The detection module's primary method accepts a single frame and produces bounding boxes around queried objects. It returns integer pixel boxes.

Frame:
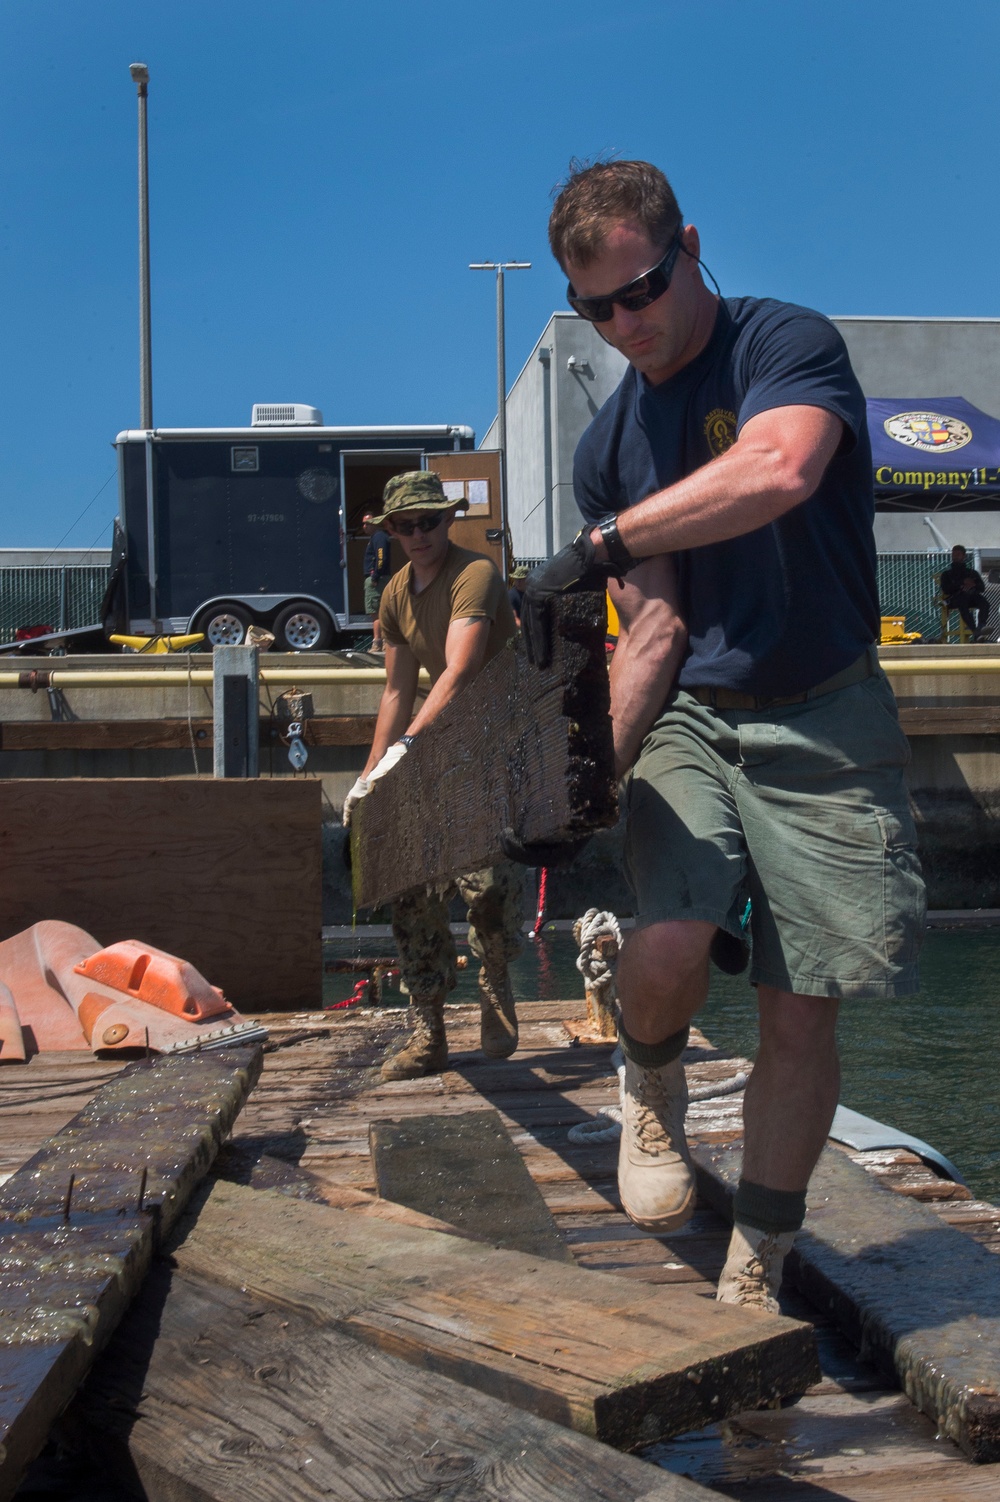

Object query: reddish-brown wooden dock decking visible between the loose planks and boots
[0,1000,1000,1502]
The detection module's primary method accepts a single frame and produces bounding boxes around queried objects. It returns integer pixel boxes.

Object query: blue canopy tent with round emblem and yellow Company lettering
[868,397,1000,511]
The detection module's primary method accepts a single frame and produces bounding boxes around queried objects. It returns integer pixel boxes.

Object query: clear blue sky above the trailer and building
[0,0,1000,547]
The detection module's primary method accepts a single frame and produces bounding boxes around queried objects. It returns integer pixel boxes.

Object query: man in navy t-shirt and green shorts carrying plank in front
[523,162,923,1310]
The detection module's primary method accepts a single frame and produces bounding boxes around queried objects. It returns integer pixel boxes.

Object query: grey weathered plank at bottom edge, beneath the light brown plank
[60,1265,715,1502]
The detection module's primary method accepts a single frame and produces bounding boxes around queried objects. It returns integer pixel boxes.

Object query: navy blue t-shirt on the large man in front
[574,297,878,698]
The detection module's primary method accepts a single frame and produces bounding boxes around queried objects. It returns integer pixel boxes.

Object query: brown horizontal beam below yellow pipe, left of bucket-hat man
[0,715,375,751]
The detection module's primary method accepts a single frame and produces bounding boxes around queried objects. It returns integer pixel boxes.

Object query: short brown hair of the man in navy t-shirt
[548,161,682,267]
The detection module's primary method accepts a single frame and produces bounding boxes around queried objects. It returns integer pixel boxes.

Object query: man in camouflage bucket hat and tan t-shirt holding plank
[344,470,523,1080]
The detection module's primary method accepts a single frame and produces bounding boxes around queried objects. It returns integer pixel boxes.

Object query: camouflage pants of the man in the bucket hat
[392,861,524,1002]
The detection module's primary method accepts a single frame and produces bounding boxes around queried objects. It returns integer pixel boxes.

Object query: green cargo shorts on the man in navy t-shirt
[625,671,925,997]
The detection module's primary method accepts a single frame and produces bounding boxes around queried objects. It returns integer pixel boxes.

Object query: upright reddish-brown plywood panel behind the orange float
[0,778,323,1011]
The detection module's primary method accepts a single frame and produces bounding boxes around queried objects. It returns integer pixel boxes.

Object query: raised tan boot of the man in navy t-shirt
[619,1057,695,1232]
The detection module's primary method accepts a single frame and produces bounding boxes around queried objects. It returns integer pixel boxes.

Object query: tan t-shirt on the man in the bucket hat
[378,542,517,683]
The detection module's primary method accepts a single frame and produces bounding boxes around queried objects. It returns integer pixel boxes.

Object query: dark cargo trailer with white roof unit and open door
[116,407,489,650]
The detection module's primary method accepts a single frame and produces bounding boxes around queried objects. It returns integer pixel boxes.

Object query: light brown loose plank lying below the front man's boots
[171,1184,817,1448]
